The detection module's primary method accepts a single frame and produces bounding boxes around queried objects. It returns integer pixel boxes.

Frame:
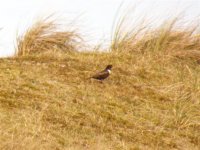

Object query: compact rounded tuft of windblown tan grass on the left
[16,17,82,56]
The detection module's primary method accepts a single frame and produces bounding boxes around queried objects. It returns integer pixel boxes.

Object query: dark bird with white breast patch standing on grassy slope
[90,65,112,81]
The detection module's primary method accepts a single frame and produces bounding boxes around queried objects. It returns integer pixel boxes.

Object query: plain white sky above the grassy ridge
[0,0,200,57]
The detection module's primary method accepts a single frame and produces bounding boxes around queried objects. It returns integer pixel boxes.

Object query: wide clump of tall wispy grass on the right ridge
[111,14,200,59]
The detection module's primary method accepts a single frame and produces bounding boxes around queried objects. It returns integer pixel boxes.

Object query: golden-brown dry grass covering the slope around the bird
[0,13,200,150]
